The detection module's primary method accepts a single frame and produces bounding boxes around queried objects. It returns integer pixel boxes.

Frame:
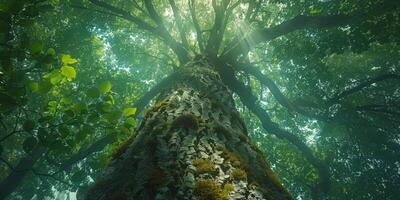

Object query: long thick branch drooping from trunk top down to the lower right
[216,63,330,195]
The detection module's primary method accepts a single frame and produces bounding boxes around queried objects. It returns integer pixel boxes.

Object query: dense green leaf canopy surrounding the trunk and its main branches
[0,0,400,199]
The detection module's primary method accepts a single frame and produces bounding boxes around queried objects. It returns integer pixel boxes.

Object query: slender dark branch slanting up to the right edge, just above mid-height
[328,74,400,105]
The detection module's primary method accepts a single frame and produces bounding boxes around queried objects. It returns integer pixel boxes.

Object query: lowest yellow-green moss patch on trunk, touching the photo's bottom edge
[194,179,228,200]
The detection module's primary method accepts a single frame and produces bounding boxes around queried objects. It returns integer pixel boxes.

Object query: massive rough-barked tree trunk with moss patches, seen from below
[87,61,291,200]
